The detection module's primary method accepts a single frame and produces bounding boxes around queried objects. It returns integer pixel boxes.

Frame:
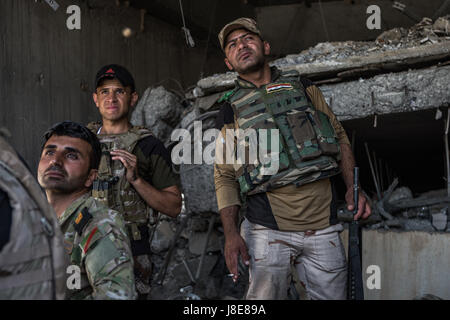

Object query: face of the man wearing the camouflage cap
[225,29,270,74]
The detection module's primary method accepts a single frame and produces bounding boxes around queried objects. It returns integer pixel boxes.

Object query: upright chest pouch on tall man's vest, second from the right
[286,111,322,161]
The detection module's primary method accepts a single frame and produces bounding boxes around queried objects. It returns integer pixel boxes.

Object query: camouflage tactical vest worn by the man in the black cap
[88,122,154,241]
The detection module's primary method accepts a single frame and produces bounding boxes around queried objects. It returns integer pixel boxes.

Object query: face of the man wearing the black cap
[93,79,137,122]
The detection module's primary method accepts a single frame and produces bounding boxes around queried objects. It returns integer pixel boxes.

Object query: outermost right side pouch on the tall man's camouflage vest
[314,110,340,155]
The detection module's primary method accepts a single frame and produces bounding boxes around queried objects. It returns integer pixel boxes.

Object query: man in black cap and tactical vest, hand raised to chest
[88,64,181,299]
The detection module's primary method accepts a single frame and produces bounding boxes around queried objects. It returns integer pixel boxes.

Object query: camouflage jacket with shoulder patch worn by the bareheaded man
[59,194,136,299]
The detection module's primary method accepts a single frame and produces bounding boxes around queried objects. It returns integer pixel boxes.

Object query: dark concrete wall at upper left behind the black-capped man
[0,0,225,170]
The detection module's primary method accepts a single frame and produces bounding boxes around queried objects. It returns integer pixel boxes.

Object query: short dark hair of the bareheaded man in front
[41,121,102,169]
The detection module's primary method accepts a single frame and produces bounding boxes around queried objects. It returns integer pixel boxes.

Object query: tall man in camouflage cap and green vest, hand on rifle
[214,18,371,299]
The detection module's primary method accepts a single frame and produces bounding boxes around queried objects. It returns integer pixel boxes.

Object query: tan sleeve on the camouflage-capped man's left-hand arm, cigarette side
[214,124,241,210]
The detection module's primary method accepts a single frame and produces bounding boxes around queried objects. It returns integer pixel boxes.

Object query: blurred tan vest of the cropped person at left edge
[0,136,68,299]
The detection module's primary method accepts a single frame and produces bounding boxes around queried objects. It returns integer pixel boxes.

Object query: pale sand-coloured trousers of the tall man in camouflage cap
[241,219,347,300]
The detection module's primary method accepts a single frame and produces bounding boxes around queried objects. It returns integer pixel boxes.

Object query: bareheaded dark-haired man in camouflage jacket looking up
[38,122,137,300]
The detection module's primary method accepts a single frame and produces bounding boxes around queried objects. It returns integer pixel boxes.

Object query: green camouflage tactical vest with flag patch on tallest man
[225,71,340,197]
